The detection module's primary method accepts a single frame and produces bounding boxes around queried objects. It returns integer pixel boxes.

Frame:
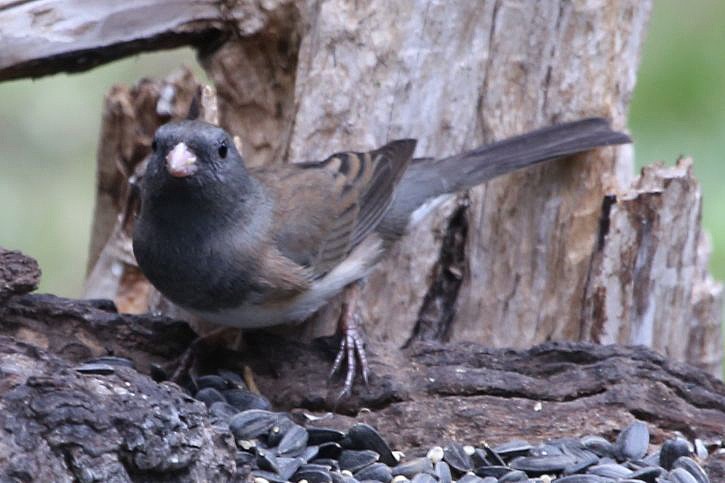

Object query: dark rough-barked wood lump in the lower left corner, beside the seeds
[0,334,236,482]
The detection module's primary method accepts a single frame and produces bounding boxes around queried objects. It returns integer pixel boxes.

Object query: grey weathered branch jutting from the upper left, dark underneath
[0,0,225,80]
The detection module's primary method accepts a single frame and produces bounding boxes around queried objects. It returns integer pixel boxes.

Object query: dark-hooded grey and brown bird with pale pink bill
[133,117,631,397]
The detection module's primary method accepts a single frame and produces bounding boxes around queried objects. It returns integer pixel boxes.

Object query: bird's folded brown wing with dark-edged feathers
[253,139,415,277]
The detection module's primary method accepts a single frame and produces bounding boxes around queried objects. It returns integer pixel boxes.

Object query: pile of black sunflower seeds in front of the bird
[185,372,710,483]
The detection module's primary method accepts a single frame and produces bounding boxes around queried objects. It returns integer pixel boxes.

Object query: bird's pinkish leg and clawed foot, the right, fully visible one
[330,282,368,399]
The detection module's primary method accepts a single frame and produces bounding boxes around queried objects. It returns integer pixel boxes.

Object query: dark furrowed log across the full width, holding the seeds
[0,250,725,481]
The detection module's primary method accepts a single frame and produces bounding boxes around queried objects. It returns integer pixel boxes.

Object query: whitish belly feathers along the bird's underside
[191,235,382,329]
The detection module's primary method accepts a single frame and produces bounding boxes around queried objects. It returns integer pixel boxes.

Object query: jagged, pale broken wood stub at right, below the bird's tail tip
[582,159,722,377]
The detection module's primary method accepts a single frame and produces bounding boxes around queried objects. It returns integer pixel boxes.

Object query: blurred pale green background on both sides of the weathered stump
[0,0,725,296]
